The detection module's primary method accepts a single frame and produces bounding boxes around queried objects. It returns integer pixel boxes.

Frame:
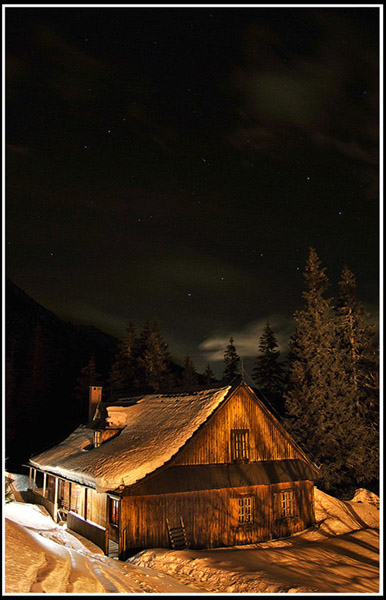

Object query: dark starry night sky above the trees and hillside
[5,6,379,374]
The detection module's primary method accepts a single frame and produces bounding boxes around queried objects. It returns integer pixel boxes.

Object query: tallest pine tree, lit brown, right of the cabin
[285,248,350,490]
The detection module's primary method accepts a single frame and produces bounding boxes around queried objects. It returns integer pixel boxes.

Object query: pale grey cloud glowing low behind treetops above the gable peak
[199,314,295,362]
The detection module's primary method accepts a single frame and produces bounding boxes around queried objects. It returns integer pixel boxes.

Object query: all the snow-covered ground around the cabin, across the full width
[4,489,379,595]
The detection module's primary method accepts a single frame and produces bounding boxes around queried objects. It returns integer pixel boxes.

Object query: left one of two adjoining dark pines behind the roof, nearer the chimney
[107,322,137,398]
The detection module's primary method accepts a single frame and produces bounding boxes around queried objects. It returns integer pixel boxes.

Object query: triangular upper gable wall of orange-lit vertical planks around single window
[173,388,302,465]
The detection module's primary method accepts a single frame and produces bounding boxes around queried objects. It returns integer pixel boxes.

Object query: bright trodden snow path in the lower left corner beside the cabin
[5,505,202,594]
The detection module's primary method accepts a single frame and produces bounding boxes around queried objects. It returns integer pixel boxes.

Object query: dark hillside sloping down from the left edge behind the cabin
[5,280,118,467]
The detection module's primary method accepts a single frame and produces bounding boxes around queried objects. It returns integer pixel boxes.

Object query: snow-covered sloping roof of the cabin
[30,386,231,492]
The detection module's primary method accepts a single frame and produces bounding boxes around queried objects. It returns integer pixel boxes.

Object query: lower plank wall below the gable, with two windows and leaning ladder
[121,481,314,549]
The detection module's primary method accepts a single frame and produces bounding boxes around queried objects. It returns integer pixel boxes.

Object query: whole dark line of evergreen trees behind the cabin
[6,249,379,497]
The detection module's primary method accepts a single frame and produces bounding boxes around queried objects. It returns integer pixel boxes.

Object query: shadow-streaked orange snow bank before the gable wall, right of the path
[128,489,379,594]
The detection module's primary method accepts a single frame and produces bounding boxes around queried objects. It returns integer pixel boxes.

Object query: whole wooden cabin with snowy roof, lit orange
[29,382,318,558]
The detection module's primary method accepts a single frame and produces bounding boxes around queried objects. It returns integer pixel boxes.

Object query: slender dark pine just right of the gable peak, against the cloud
[252,323,284,413]
